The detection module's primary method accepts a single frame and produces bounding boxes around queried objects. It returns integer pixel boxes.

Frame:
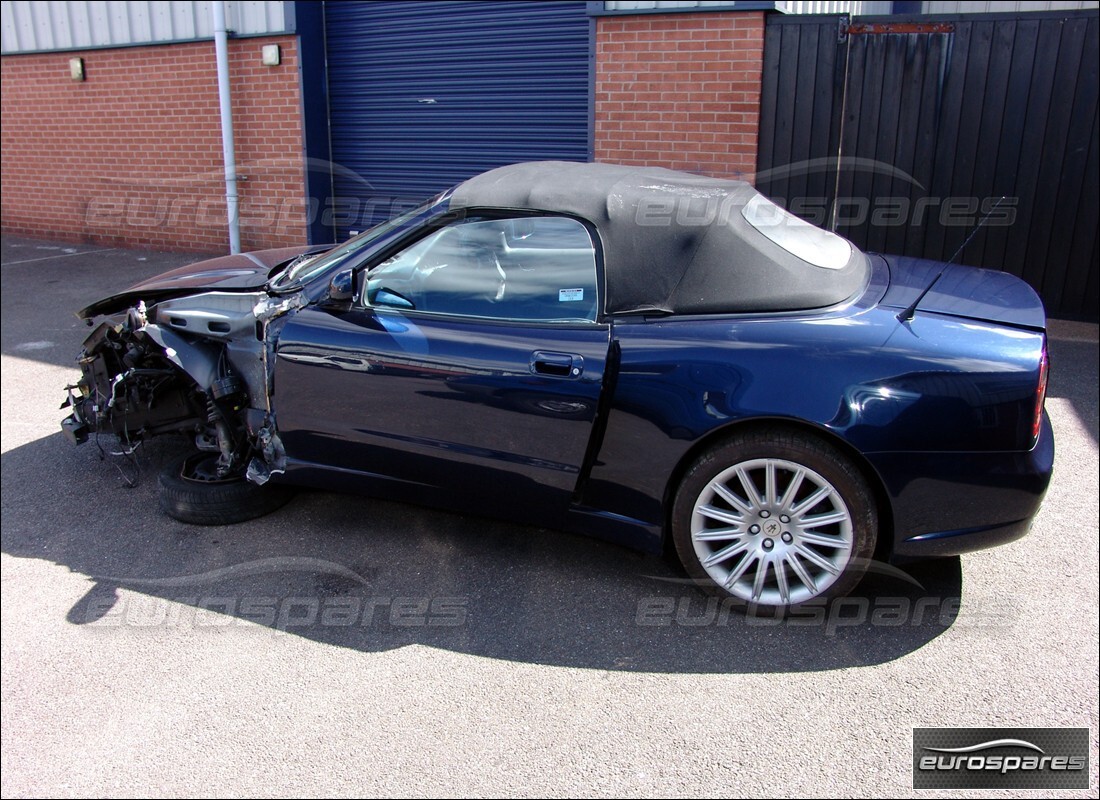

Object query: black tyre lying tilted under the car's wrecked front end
[160,452,294,525]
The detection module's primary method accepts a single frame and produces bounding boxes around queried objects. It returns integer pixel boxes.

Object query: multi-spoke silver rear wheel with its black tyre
[672,429,878,611]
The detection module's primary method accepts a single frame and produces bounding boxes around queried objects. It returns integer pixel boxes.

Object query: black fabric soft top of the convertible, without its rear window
[450,161,870,314]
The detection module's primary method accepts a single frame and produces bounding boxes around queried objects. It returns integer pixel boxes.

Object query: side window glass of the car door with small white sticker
[366,217,598,322]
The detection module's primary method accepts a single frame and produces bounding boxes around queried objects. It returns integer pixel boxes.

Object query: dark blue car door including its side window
[274,217,609,513]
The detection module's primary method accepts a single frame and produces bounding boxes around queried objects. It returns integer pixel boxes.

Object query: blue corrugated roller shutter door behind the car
[325,2,592,239]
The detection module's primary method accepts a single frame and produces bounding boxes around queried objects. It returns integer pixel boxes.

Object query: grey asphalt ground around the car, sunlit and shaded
[0,237,1100,797]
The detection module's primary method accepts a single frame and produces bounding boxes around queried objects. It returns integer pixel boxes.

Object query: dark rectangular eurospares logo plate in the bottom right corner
[913,727,1089,789]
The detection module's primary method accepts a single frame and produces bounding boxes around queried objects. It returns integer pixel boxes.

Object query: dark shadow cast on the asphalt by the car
[2,434,965,673]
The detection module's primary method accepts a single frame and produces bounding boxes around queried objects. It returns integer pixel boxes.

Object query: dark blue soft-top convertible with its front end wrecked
[63,162,1054,610]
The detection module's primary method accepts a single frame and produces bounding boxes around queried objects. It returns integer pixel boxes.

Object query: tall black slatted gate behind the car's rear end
[757,11,1100,319]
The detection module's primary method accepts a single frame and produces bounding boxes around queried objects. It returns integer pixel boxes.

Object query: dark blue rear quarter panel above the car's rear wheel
[584,306,1044,539]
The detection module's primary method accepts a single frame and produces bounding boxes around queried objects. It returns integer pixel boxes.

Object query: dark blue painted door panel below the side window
[275,307,609,513]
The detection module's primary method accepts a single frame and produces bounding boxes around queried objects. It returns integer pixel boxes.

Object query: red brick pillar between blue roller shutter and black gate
[595,12,765,179]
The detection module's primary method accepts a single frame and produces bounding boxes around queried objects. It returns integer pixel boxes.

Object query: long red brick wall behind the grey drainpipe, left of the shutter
[0,36,306,253]
